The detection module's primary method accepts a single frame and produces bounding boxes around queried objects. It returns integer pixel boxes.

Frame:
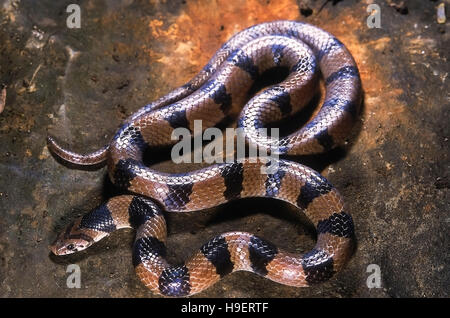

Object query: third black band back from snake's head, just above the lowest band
[132,236,166,267]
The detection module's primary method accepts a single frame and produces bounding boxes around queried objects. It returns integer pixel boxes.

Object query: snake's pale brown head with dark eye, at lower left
[49,222,94,255]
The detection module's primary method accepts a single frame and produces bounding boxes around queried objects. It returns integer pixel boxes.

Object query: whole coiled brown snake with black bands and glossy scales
[47,20,362,297]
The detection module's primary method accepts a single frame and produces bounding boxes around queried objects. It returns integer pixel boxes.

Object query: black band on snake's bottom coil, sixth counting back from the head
[248,236,278,276]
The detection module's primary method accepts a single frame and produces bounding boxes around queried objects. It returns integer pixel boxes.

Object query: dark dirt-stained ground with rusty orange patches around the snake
[0,0,450,297]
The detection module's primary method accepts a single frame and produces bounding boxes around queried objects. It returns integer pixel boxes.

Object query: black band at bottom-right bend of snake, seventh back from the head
[302,249,334,285]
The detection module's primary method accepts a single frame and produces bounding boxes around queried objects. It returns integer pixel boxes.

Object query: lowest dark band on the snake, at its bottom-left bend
[158,265,191,296]
